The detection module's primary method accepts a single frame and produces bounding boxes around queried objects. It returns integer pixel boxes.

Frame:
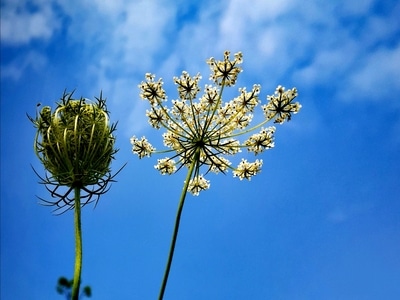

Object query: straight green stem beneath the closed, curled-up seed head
[71,187,82,300]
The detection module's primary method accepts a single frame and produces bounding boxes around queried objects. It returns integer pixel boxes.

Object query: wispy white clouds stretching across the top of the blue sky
[2,0,400,125]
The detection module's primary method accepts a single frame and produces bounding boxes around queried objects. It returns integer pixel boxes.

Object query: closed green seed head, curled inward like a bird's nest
[30,93,117,211]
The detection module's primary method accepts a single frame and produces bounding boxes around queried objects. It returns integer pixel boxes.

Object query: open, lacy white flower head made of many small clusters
[131,51,301,195]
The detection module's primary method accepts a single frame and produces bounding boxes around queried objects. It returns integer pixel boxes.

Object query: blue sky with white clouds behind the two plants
[1,0,400,300]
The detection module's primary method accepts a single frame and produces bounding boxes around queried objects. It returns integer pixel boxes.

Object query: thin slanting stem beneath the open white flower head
[158,150,200,300]
